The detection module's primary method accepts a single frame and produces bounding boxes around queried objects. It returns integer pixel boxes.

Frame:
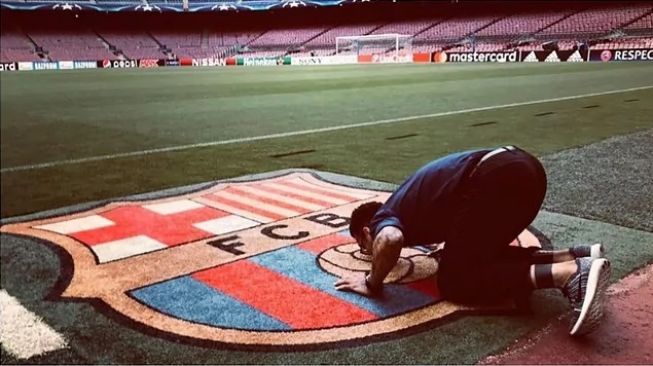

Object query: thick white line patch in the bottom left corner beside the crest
[0,290,66,359]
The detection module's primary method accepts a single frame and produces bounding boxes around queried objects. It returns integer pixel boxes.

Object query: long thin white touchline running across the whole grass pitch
[0,85,653,173]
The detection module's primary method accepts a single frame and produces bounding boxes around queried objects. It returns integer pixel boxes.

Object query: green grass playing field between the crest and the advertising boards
[1,63,653,217]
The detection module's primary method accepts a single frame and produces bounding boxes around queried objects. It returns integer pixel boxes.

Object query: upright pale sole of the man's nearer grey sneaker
[569,258,611,335]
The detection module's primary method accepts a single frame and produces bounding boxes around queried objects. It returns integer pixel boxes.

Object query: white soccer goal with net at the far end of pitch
[336,33,413,62]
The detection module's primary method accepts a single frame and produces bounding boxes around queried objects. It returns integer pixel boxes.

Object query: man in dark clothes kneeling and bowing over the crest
[335,146,610,335]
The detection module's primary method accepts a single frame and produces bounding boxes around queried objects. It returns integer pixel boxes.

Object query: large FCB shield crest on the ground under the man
[0,172,540,347]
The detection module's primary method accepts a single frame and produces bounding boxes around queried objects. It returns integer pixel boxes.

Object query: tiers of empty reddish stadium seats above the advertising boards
[0,0,653,61]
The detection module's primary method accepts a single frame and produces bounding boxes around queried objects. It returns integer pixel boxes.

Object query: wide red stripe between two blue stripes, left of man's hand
[193,261,377,329]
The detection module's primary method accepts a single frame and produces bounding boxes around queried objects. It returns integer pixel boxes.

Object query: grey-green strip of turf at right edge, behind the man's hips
[543,130,653,232]
